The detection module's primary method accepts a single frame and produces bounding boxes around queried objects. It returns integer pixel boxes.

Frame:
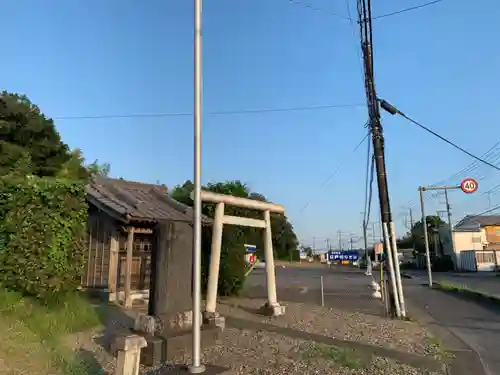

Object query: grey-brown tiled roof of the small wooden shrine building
[87,177,211,223]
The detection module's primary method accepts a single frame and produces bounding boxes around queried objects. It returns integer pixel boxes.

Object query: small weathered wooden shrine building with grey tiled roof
[81,177,209,306]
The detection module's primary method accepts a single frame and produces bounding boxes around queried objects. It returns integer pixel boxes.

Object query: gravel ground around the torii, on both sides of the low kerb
[60,299,448,375]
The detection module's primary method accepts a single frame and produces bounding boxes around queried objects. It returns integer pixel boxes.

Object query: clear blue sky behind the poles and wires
[0,0,500,247]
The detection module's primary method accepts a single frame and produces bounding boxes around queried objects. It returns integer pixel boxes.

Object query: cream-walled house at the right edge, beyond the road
[453,215,500,271]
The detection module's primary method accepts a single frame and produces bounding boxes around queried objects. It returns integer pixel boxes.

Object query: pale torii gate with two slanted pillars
[197,190,285,321]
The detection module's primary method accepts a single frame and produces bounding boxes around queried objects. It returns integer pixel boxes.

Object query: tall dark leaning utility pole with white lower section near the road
[357,0,406,318]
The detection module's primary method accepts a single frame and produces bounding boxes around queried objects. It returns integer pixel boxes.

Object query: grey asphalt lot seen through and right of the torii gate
[246,266,384,315]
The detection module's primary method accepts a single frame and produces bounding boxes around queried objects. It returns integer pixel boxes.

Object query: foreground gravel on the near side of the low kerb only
[66,328,444,375]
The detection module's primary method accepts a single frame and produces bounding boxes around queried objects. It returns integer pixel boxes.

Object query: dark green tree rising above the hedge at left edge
[0,91,71,177]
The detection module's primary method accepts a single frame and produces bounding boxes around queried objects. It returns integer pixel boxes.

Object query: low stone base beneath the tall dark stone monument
[141,325,222,367]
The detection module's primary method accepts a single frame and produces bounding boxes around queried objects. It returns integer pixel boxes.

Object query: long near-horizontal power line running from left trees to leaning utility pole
[52,104,365,120]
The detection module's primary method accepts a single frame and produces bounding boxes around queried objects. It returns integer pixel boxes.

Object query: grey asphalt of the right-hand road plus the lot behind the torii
[247,266,500,375]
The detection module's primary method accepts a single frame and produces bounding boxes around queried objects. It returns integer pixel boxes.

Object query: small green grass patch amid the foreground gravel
[301,342,364,369]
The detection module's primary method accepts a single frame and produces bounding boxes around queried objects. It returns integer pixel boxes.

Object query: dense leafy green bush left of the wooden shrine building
[0,177,87,301]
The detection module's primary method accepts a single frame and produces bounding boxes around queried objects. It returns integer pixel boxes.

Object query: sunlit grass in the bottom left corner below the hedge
[0,289,100,375]
